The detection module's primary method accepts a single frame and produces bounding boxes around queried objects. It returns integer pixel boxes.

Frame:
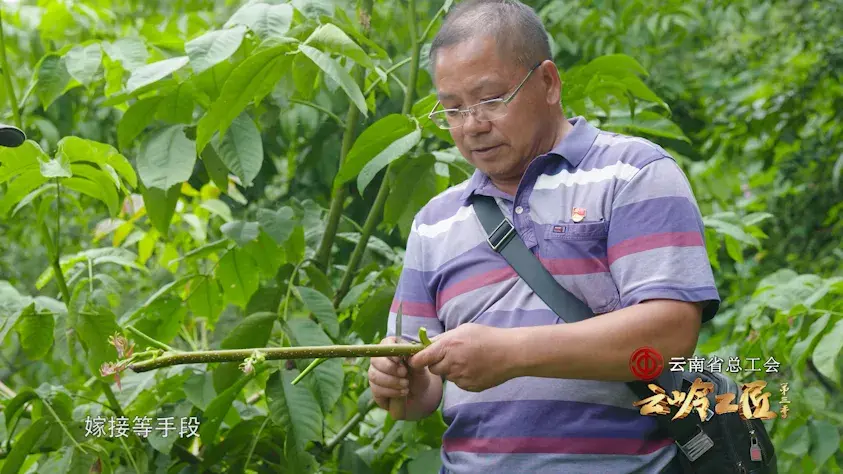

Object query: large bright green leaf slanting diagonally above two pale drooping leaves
[196,44,292,152]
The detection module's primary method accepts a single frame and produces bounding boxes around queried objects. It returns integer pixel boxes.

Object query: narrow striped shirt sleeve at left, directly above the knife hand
[386,220,445,342]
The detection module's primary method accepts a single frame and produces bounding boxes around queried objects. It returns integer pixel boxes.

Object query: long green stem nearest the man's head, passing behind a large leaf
[334,0,421,306]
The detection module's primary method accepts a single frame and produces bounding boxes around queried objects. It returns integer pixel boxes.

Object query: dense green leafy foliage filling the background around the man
[0,0,843,474]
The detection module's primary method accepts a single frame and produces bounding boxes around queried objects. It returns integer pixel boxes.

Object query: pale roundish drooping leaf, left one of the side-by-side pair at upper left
[137,125,196,190]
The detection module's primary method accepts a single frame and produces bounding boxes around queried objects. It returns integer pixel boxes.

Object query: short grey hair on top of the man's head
[428,0,553,72]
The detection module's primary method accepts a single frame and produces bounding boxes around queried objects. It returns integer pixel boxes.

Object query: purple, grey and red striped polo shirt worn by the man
[387,117,720,474]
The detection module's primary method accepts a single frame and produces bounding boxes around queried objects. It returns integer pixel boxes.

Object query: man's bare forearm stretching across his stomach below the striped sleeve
[511,301,700,381]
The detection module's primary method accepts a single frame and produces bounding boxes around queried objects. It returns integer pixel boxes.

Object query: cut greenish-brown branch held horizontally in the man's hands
[128,344,424,372]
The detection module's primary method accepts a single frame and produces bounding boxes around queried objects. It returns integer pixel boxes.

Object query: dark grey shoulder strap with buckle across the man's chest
[472,194,704,458]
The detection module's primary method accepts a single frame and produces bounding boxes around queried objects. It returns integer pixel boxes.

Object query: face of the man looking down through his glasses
[434,36,550,183]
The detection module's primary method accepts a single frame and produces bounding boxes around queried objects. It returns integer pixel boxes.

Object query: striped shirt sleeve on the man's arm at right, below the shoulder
[607,156,720,322]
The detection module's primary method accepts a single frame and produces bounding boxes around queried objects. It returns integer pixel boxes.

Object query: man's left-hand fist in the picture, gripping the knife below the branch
[369,336,442,419]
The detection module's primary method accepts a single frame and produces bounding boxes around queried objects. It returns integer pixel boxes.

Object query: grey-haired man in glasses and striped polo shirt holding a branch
[369,0,719,474]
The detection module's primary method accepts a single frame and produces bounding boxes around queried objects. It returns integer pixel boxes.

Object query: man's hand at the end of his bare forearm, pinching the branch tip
[408,323,516,392]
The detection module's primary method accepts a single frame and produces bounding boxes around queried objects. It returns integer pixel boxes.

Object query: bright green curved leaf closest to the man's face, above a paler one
[334,114,417,188]
